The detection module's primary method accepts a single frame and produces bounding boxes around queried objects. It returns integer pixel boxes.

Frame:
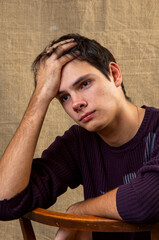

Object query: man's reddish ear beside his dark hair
[109,62,122,87]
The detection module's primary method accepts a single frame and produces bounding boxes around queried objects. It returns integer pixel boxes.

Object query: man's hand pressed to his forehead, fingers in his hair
[36,39,77,100]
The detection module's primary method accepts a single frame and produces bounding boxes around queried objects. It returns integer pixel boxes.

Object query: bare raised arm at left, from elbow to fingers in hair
[0,40,76,200]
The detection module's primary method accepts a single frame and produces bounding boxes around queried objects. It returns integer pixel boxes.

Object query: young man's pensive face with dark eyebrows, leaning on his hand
[57,60,120,133]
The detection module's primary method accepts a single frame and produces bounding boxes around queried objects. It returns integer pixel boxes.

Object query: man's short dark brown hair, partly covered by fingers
[32,34,130,100]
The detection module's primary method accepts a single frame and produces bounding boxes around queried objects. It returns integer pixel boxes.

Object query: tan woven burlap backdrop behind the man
[0,0,159,240]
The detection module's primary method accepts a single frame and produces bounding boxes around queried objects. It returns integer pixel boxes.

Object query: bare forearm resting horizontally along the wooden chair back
[67,188,121,220]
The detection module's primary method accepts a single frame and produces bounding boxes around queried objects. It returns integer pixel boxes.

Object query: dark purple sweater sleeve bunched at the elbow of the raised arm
[0,126,81,220]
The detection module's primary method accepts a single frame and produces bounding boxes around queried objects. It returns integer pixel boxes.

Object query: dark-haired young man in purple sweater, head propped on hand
[0,34,159,240]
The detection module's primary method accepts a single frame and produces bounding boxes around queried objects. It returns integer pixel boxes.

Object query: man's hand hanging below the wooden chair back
[55,228,92,240]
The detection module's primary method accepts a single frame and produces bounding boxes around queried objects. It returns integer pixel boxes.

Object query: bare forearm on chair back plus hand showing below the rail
[55,188,121,240]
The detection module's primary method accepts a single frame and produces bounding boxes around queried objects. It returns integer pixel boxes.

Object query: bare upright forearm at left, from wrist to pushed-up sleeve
[0,92,49,200]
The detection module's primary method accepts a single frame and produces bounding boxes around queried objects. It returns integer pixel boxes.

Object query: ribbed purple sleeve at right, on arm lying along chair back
[117,156,159,223]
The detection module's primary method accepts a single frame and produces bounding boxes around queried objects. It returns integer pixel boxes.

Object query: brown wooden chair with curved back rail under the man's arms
[19,208,159,240]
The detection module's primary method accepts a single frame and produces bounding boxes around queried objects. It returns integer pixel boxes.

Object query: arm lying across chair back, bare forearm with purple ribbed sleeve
[67,158,159,223]
